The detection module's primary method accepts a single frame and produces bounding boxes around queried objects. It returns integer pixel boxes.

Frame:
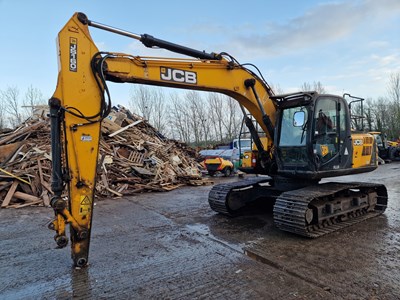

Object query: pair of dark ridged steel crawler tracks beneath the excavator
[208,177,387,238]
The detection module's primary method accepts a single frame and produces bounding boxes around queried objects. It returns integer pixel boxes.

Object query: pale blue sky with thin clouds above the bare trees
[0,0,400,104]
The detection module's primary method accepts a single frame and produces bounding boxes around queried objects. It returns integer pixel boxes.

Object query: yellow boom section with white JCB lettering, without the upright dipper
[107,57,276,132]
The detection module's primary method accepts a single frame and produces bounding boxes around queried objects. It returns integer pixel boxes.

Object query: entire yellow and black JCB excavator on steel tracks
[49,13,387,267]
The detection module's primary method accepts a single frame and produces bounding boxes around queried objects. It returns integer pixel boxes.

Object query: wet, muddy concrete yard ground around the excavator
[0,163,400,299]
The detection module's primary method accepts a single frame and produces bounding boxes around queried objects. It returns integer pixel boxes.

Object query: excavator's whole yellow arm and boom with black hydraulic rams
[49,13,276,267]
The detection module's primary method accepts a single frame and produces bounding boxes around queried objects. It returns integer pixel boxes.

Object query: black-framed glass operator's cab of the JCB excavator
[272,92,352,180]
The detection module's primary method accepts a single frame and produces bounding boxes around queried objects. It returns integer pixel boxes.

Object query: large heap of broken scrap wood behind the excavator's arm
[0,107,210,208]
